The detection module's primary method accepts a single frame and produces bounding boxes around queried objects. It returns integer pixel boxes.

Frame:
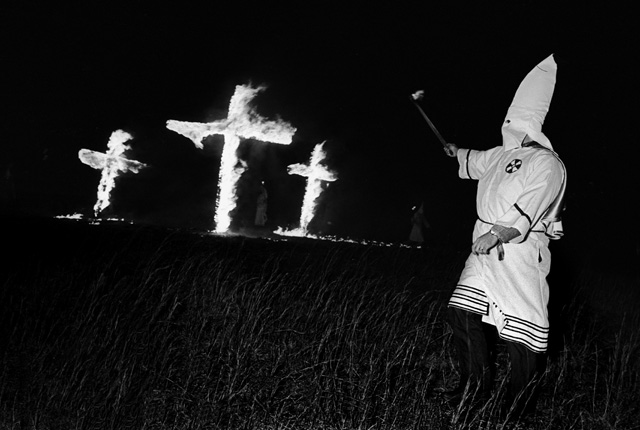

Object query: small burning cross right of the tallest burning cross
[287,142,338,235]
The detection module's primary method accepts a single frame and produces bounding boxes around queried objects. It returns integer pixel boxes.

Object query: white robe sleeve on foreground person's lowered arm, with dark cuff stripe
[495,154,564,243]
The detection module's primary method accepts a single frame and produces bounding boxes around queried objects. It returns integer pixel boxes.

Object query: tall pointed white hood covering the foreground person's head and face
[502,55,558,151]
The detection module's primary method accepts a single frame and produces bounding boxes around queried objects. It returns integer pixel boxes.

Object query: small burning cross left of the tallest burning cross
[78,130,146,216]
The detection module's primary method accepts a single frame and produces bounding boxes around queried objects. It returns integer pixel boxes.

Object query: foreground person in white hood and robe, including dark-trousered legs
[445,56,566,420]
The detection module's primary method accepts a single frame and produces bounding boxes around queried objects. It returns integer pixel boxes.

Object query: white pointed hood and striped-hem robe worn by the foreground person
[449,56,566,352]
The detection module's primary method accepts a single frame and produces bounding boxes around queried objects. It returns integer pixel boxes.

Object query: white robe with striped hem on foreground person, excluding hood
[449,146,566,352]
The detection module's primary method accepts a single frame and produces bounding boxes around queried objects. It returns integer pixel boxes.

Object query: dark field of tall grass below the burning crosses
[0,220,640,429]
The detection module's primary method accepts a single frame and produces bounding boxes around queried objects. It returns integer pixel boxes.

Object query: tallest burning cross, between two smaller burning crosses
[167,85,296,233]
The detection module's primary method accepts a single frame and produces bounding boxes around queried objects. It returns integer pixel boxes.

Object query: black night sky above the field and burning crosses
[0,1,638,266]
